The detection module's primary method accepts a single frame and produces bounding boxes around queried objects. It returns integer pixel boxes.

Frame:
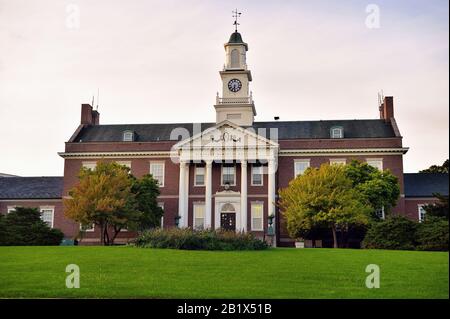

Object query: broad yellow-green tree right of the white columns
[279,164,371,248]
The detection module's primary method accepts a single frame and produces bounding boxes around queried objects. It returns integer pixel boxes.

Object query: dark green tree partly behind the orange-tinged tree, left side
[130,174,164,230]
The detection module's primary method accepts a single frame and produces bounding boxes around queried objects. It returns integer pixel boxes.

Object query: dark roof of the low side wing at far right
[403,173,448,197]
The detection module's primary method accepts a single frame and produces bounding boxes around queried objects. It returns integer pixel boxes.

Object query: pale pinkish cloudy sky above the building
[0,0,449,176]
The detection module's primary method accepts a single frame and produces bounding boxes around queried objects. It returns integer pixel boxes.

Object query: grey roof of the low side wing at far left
[0,176,63,199]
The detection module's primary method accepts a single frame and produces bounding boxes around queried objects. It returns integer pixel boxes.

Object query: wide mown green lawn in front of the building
[0,246,449,298]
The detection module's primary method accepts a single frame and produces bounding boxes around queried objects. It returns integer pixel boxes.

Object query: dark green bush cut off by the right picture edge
[417,216,449,251]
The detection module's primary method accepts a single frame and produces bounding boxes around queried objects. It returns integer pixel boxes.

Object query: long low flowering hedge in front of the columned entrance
[134,228,269,250]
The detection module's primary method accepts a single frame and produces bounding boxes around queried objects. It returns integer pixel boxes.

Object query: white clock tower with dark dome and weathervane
[214,26,256,126]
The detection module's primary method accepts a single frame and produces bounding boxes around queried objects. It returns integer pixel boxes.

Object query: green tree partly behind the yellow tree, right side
[345,160,400,219]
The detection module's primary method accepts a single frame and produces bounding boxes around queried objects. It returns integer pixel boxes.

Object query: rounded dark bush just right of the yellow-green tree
[362,216,418,250]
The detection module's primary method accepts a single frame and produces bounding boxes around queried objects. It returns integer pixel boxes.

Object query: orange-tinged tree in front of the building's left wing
[64,161,139,245]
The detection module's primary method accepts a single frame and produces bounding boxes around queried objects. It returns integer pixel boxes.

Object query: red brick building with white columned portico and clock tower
[0,32,448,246]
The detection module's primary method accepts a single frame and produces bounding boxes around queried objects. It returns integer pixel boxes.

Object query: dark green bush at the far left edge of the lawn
[0,207,64,246]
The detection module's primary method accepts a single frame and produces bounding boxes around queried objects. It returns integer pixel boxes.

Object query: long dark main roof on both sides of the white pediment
[73,120,396,142]
